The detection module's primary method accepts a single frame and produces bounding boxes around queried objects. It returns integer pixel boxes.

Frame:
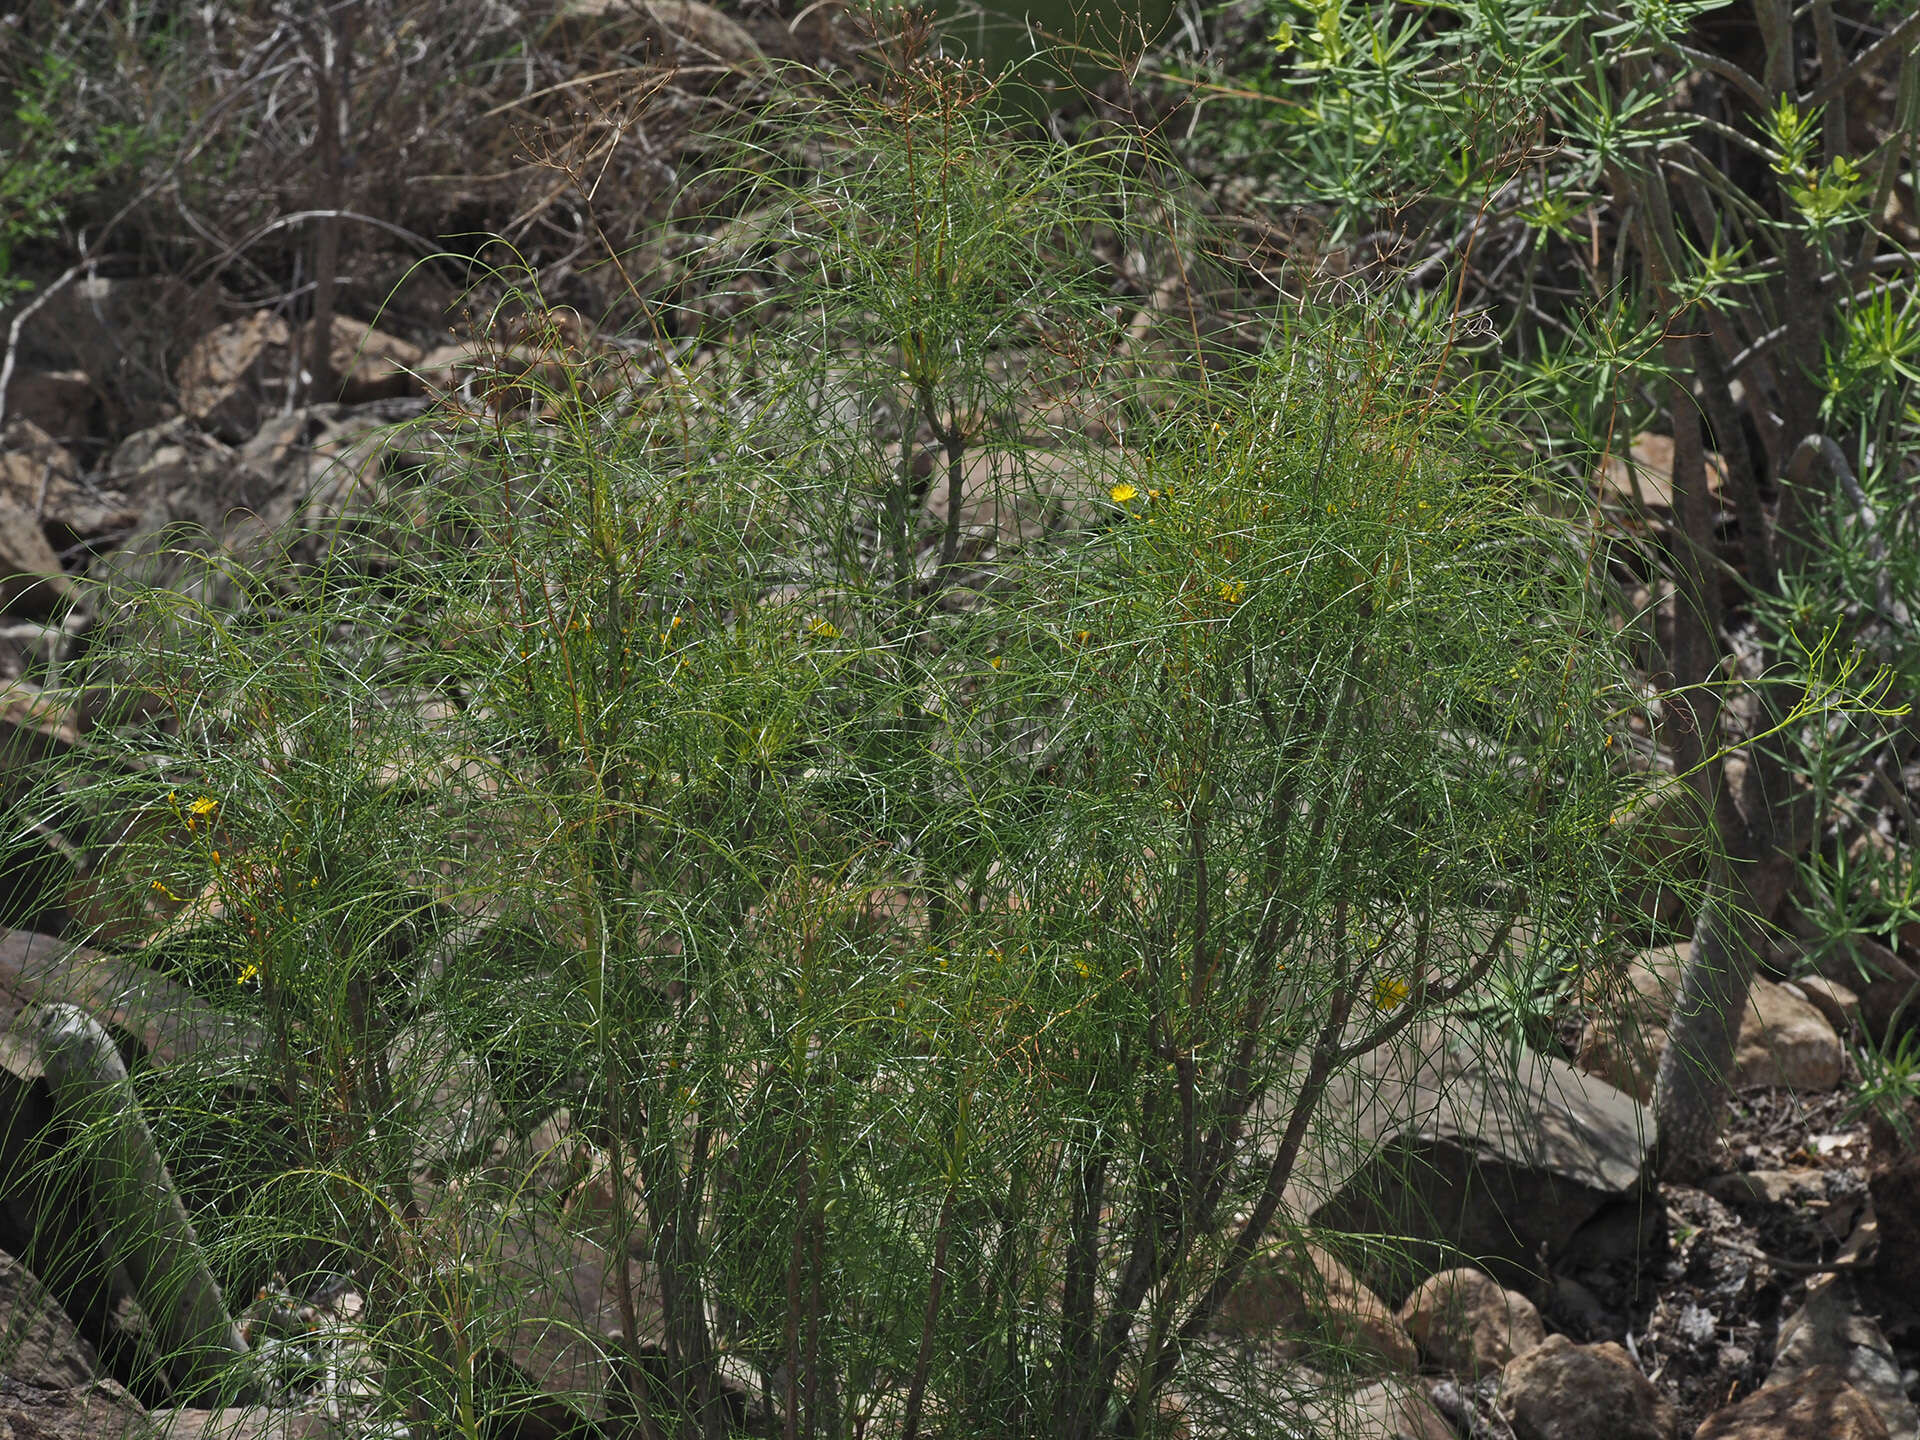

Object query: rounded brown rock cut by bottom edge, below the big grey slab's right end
[1500,1334,1674,1440]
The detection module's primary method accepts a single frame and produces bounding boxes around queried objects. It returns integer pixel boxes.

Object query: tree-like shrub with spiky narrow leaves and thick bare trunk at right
[1167,0,1920,1171]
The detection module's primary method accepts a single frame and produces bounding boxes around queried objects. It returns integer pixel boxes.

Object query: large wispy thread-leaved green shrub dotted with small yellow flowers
[22,53,1630,1438]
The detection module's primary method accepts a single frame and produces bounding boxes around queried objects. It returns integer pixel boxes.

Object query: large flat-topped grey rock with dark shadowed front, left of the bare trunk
[1290,1021,1659,1304]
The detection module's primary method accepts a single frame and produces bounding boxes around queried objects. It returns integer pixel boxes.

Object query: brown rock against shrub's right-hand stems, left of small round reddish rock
[1215,1244,1419,1371]
